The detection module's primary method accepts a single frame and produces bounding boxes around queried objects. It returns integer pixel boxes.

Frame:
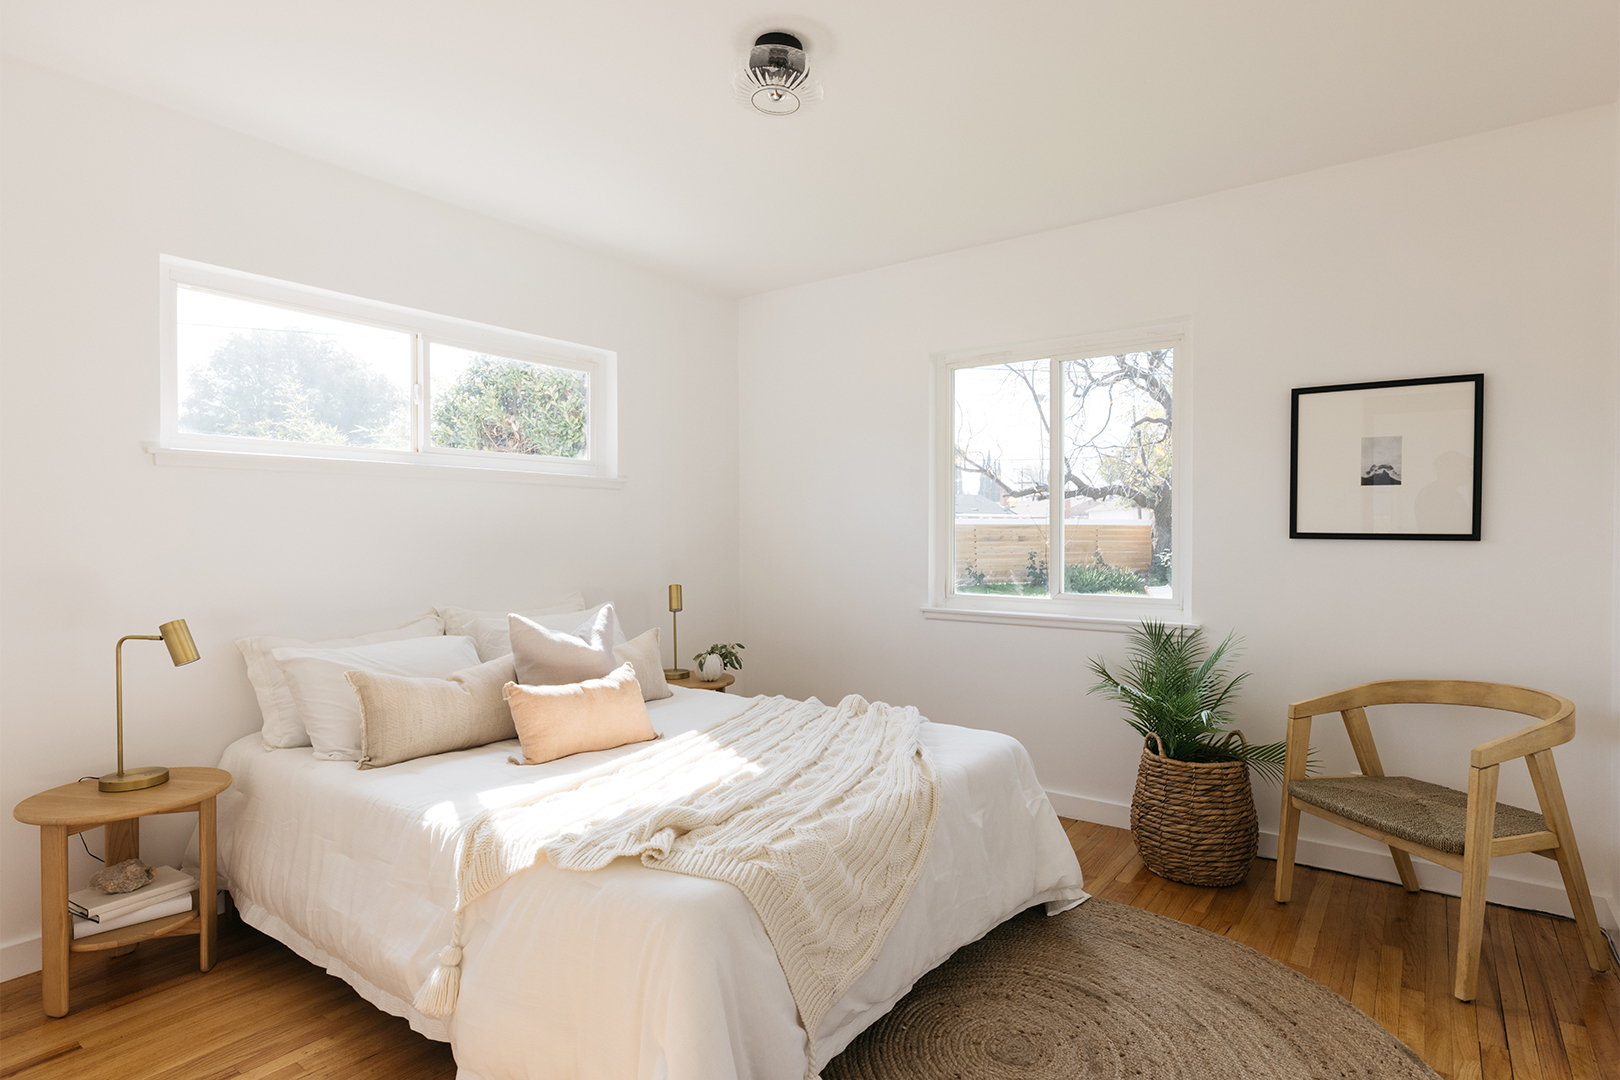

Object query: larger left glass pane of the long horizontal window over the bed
[175,287,411,450]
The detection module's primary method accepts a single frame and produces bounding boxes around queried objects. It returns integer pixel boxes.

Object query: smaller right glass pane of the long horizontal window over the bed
[431,342,590,460]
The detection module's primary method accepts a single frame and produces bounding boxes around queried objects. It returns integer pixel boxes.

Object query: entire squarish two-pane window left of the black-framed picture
[925,325,1187,625]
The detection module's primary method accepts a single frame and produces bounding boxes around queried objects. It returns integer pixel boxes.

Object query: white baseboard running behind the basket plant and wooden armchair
[1047,790,1620,934]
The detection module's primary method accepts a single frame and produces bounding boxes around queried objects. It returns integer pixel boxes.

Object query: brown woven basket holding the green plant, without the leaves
[1131,735,1260,886]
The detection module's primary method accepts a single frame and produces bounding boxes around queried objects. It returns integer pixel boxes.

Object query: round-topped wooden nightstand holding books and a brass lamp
[11,767,230,1017]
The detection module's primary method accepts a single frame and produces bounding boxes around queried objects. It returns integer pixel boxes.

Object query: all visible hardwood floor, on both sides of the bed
[0,821,1620,1080]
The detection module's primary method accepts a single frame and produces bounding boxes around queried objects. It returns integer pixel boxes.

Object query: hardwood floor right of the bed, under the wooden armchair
[1064,821,1620,1080]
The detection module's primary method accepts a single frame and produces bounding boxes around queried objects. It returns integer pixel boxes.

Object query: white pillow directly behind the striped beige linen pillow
[271,636,478,761]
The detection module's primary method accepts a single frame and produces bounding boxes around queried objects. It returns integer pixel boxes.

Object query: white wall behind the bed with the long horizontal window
[0,63,737,978]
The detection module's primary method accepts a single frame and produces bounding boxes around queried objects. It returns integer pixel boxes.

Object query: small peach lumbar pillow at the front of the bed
[505,664,658,764]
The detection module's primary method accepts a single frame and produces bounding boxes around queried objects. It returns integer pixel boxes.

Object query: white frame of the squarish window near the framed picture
[922,319,1194,631]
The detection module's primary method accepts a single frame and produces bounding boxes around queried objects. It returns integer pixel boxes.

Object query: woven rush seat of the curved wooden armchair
[1288,776,1547,855]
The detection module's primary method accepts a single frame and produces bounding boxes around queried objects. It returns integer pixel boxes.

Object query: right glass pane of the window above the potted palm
[1063,348,1175,596]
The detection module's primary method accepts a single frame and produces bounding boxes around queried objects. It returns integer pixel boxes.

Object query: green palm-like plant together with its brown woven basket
[1090,622,1286,886]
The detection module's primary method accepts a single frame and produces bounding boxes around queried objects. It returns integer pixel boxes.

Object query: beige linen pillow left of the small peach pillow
[343,656,517,769]
